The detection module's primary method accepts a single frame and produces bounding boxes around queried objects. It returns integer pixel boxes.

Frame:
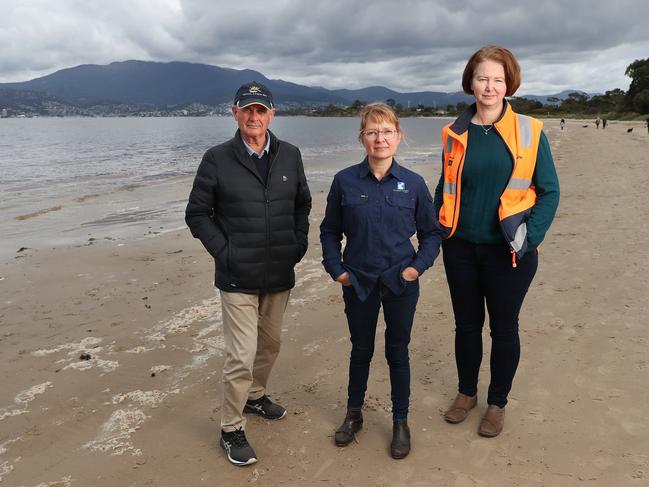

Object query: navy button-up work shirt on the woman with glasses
[320,158,442,301]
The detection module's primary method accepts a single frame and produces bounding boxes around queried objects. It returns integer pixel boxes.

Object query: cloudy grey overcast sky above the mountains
[0,0,649,95]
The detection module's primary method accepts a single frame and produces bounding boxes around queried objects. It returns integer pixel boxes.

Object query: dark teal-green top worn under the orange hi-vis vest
[435,123,559,252]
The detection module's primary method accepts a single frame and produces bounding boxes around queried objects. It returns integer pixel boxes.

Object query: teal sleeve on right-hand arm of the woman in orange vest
[527,132,559,252]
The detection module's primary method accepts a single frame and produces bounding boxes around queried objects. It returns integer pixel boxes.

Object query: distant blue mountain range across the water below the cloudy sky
[0,60,588,112]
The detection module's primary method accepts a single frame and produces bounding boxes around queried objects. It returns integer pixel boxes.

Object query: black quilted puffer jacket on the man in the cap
[185,131,311,293]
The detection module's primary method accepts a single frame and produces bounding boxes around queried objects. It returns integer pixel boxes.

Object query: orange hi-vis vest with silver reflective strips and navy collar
[439,100,543,267]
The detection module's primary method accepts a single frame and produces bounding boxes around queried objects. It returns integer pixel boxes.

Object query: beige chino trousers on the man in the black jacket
[221,290,291,431]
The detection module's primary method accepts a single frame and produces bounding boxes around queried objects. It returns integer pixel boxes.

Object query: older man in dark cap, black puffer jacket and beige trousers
[185,82,311,465]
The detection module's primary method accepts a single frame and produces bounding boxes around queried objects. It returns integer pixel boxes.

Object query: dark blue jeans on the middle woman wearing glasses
[343,281,419,420]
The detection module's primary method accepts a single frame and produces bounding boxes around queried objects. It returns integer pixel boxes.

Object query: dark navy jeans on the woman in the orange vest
[442,238,538,407]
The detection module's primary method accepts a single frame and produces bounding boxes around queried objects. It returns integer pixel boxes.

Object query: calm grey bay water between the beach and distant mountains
[0,117,447,260]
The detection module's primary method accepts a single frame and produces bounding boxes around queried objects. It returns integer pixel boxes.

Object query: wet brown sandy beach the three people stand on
[0,120,649,487]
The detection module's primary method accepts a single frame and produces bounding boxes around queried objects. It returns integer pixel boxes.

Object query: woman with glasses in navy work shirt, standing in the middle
[320,103,441,459]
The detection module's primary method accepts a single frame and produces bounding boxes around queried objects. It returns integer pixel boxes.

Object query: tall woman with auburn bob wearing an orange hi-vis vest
[435,46,559,437]
